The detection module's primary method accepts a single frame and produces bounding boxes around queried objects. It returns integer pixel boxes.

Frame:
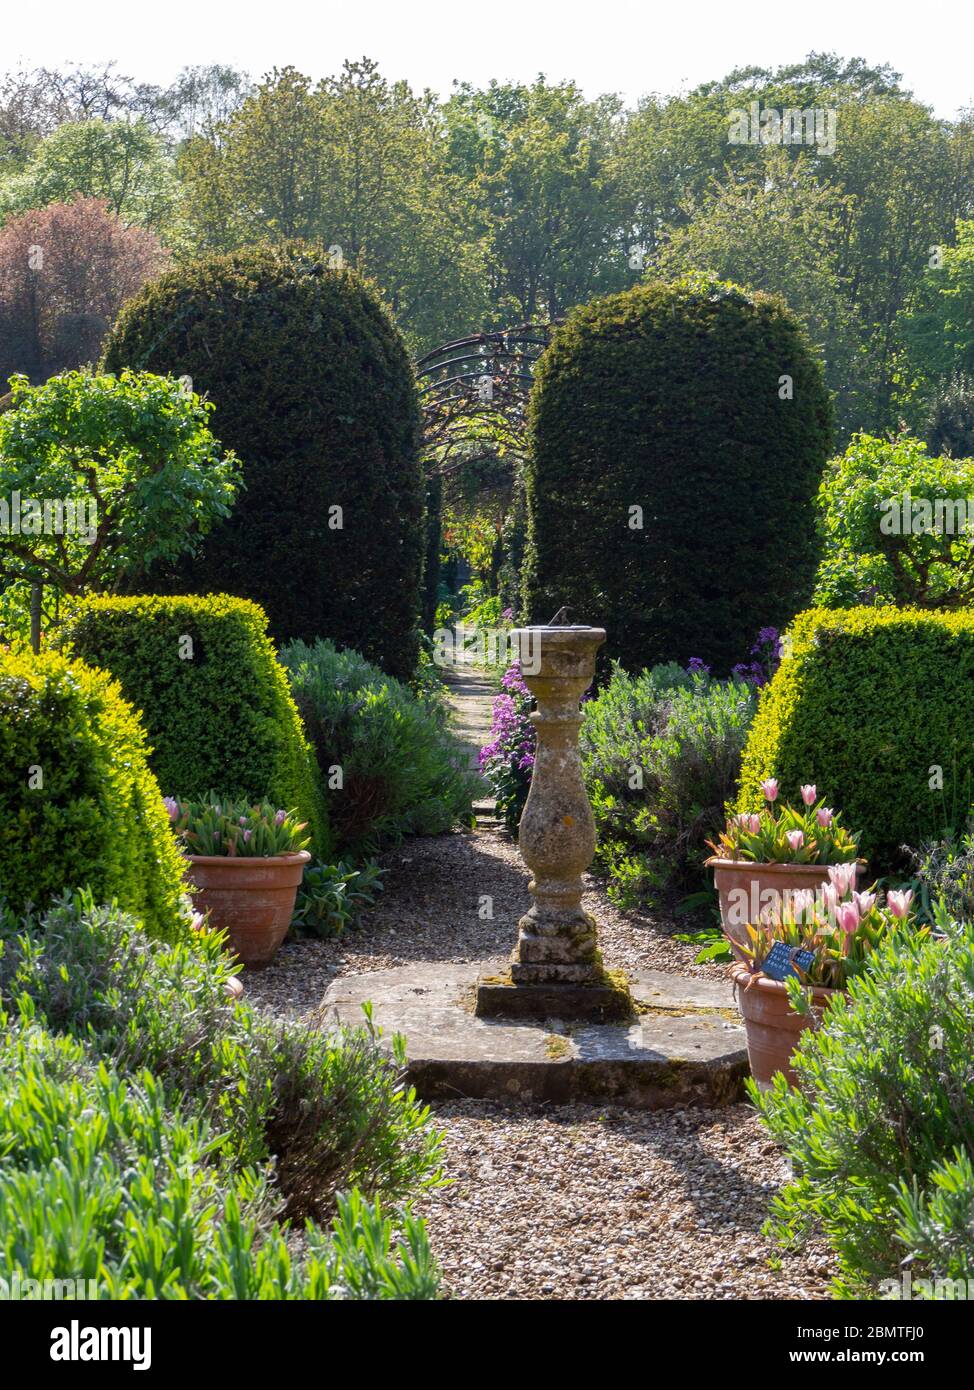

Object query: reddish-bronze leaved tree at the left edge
[0,195,167,391]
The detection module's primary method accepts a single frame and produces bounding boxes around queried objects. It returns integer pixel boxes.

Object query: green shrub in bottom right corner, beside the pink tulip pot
[752,916,974,1297]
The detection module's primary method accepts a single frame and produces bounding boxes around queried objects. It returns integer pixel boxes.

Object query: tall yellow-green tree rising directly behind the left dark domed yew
[185,60,484,348]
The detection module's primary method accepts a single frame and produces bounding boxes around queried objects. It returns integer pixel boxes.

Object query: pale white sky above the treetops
[0,0,974,117]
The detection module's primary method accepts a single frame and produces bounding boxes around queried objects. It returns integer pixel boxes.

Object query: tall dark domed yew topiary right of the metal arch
[525,278,831,673]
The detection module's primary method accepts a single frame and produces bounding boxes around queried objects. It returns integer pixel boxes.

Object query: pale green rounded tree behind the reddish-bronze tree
[0,120,178,240]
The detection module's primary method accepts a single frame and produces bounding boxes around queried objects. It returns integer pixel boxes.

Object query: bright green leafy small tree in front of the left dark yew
[0,371,238,608]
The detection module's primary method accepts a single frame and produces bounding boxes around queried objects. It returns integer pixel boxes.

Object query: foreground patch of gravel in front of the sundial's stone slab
[418,1101,831,1300]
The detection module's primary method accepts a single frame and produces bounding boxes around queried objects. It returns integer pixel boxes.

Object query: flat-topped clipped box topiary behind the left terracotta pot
[64,594,329,855]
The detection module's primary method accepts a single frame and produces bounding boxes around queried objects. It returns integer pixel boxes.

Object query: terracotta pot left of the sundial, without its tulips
[186,849,311,965]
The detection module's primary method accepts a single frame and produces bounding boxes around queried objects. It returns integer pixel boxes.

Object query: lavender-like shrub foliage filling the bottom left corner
[0,895,439,1298]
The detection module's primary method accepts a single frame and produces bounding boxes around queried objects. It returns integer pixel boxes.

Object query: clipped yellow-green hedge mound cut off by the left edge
[0,651,186,938]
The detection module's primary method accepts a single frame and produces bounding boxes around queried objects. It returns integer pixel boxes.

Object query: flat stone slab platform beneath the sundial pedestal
[321,960,748,1109]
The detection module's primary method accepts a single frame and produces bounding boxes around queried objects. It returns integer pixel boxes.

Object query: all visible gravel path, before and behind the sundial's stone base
[238,682,834,1300]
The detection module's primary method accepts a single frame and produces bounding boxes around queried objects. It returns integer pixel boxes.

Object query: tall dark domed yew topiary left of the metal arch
[104,243,424,678]
